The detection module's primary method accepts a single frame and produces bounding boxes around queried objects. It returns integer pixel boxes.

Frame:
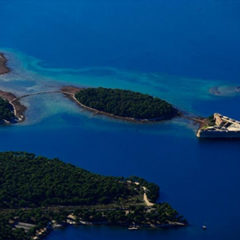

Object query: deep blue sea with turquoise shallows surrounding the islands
[0,0,240,240]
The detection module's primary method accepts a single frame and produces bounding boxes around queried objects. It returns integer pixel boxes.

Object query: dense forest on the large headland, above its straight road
[0,152,137,208]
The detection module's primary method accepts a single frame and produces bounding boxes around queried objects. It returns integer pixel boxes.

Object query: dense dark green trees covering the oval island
[75,88,178,120]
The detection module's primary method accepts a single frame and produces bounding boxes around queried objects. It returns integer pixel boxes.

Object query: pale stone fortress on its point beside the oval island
[197,113,240,139]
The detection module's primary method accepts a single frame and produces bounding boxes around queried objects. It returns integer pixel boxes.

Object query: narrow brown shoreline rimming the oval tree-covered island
[60,86,181,123]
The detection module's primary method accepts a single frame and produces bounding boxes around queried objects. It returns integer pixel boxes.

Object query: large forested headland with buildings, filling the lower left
[0,152,187,240]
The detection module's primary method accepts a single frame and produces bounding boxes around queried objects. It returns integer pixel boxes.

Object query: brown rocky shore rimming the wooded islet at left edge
[0,90,27,123]
